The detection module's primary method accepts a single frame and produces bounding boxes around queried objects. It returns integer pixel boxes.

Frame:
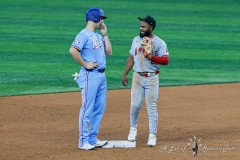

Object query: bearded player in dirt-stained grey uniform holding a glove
[122,16,169,147]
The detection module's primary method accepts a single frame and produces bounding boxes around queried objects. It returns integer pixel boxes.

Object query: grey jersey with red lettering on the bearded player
[130,35,169,72]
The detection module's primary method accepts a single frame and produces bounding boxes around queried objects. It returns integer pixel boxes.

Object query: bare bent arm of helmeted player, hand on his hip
[69,46,98,69]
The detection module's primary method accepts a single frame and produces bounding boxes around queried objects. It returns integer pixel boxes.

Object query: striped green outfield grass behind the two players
[0,0,240,96]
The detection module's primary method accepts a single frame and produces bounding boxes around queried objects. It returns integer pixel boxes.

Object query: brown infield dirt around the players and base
[0,83,240,160]
